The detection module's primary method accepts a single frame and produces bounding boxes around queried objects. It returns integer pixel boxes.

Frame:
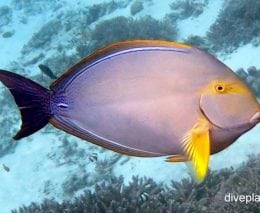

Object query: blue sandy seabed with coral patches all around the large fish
[0,0,260,213]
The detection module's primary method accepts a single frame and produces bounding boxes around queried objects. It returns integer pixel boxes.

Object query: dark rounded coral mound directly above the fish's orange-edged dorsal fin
[77,16,177,57]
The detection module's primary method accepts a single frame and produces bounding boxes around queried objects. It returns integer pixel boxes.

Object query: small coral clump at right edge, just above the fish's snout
[236,66,260,98]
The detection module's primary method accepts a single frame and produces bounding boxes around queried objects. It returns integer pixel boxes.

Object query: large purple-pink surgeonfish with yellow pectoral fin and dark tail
[0,40,260,182]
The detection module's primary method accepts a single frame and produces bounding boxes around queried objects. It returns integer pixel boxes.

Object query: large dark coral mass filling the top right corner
[207,0,260,53]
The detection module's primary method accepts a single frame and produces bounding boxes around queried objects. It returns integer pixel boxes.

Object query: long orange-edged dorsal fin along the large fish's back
[50,40,192,89]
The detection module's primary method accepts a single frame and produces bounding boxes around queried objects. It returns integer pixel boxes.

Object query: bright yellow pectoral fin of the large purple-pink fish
[183,120,210,182]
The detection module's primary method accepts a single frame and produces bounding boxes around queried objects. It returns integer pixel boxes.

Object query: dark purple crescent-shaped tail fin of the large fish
[0,70,52,140]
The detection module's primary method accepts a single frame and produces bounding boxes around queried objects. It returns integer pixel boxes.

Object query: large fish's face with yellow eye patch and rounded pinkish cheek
[200,78,260,130]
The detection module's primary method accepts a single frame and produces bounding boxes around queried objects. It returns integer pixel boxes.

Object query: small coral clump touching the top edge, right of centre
[170,0,208,19]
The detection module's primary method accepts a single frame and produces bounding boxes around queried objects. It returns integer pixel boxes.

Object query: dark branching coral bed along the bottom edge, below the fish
[12,155,260,213]
